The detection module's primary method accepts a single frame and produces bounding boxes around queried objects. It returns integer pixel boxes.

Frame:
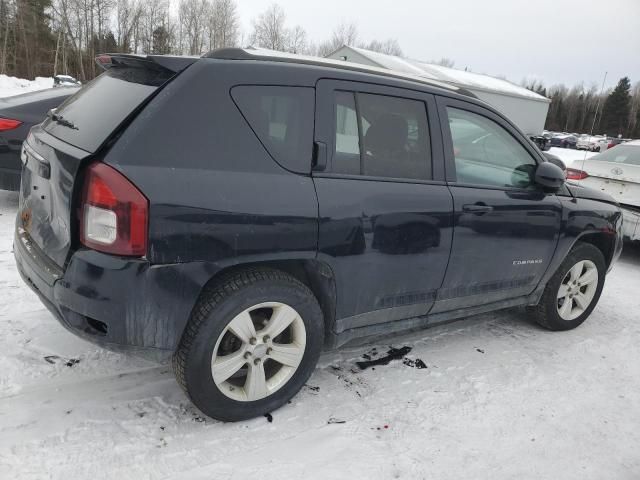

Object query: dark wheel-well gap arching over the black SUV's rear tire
[198,259,336,341]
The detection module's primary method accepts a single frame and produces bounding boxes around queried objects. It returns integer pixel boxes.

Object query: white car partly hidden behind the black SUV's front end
[567,140,640,240]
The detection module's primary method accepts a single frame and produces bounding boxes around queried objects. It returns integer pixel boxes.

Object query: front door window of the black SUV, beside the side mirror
[447,107,536,188]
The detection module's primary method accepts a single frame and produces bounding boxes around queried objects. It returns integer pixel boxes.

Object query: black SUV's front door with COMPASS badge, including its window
[432,97,561,313]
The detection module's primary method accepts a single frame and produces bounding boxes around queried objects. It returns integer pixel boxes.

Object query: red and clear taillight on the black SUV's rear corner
[80,163,149,256]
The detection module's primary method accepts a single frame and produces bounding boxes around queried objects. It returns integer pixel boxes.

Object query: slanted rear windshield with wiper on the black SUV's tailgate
[43,67,173,153]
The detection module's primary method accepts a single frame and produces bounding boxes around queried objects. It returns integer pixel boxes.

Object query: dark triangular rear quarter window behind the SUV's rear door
[231,85,314,173]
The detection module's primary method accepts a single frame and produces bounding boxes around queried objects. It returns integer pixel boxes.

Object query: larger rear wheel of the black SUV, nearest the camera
[173,269,324,421]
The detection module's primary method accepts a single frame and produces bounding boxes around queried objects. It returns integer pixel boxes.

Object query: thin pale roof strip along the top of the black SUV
[202,48,477,99]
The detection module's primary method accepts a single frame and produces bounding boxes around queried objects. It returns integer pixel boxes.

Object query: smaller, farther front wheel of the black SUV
[532,243,607,331]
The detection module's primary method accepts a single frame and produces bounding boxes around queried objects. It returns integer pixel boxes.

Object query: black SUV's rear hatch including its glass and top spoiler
[17,55,193,268]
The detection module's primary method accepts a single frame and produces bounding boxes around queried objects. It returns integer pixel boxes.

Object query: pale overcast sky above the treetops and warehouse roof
[238,0,640,87]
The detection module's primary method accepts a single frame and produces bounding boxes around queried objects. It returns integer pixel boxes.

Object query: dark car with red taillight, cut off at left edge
[0,86,78,190]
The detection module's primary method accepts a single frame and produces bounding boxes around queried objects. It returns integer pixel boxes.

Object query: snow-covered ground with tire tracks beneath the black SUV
[0,188,640,480]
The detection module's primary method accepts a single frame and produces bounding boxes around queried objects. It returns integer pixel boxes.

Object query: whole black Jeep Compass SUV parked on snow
[14,49,622,420]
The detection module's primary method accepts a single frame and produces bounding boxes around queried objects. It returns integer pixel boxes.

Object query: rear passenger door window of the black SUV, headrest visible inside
[332,91,432,180]
